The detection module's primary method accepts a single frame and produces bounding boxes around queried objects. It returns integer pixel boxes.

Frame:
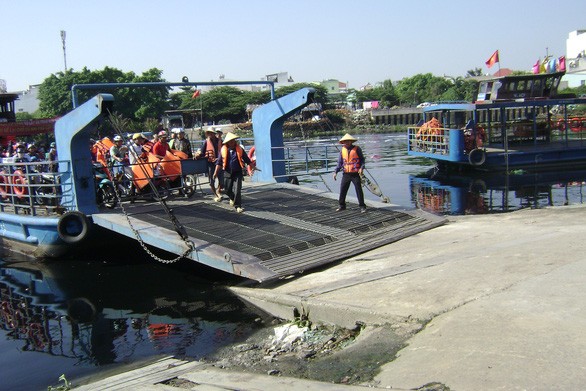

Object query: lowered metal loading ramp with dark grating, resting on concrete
[92,183,445,282]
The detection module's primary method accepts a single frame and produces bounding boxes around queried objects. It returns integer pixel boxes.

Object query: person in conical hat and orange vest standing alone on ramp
[334,133,366,213]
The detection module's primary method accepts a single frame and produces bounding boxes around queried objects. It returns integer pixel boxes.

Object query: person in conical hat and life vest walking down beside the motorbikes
[214,132,251,213]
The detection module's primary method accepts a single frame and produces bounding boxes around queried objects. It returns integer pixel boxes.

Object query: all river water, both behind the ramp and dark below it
[0,133,586,390]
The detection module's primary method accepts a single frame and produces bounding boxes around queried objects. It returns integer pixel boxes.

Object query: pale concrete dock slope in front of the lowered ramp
[73,206,586,390]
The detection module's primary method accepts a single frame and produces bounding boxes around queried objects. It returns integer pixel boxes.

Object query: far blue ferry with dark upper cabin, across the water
[407,72,586,171]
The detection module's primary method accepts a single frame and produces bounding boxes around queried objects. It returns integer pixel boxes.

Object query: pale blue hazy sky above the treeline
[0,0,586,91]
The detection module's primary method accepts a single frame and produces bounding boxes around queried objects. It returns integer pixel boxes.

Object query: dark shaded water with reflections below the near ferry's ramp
[0,259,264,389]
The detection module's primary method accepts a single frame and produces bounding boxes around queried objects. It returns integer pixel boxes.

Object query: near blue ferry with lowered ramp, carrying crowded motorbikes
[0,81,445,282]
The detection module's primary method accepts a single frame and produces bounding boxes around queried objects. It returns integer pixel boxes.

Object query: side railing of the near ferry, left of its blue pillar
[0,158,71,216]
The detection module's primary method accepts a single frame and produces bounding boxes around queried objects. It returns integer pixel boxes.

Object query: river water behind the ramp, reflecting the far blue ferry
[288,133,586,215]
